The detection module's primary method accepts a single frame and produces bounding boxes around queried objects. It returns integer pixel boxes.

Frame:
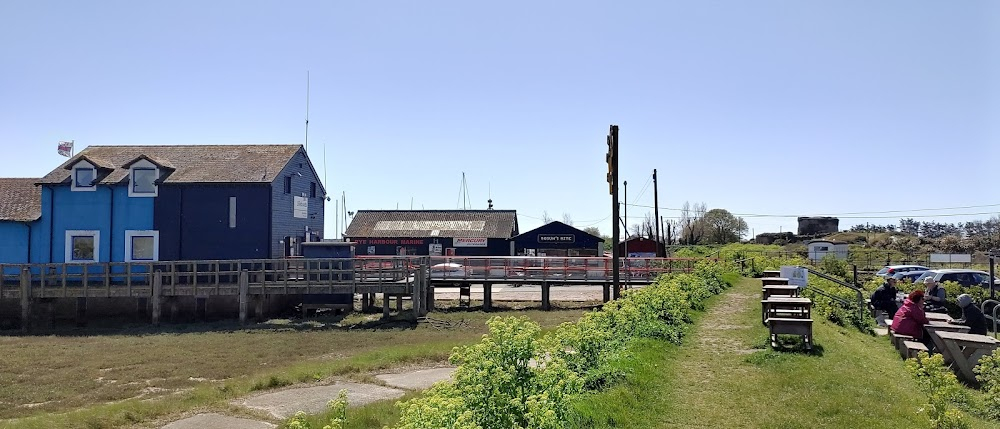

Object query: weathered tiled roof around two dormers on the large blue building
[39,145,302,184]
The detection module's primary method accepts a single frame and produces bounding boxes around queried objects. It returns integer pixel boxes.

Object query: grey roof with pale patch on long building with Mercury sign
[344,210,517,238]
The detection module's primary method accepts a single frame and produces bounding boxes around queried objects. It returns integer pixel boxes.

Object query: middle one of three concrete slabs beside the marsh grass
[234,382,404,419]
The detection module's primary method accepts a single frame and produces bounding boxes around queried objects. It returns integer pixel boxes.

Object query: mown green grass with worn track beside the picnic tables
[574,280,996,428]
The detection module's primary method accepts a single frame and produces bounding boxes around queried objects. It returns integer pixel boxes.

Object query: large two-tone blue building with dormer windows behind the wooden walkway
[0,145,326,263]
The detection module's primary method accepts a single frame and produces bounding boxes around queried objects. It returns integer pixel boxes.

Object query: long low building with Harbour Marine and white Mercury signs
[344,210,518,256]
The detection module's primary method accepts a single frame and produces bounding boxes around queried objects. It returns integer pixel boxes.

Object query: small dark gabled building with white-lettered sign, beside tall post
[511,221,604,256]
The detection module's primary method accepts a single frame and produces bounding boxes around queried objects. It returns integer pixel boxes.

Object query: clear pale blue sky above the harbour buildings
[0,0,1000,237]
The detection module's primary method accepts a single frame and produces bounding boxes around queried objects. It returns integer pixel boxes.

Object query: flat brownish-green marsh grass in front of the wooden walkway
[0,300,583,428]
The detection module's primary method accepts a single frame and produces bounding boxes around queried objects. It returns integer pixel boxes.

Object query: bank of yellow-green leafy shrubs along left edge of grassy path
[397,262,738,429]
